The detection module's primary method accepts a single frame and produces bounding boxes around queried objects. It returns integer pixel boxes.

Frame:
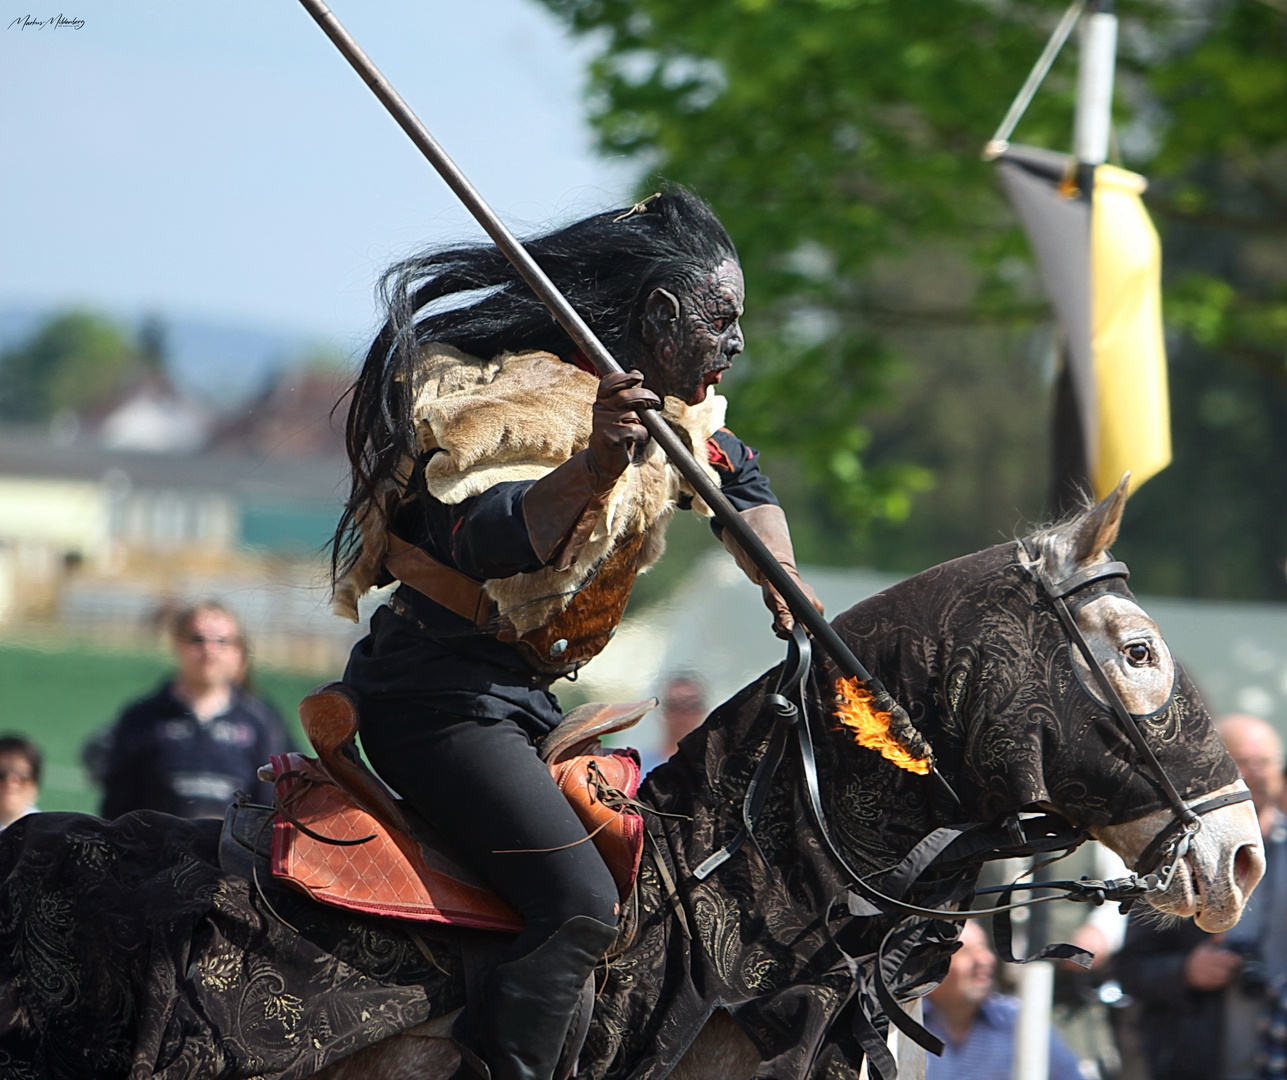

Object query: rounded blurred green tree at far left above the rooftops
[0,312,143,422]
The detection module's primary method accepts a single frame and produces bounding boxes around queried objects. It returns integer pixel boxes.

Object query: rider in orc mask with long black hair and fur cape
[326,189,821,1080]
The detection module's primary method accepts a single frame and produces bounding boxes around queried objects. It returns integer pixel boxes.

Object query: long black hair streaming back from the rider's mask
[331,187,737,592]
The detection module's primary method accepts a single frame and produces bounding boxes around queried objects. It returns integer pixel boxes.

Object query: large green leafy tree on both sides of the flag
[543,0,1287,595]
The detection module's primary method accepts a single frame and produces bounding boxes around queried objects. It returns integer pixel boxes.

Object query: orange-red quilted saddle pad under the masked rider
[272,750,644,931]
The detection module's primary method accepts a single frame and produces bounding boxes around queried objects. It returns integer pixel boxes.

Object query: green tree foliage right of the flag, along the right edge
[1118,0,1287,600]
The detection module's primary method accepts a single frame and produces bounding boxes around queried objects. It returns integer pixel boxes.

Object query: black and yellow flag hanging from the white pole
[997,147,1171,499]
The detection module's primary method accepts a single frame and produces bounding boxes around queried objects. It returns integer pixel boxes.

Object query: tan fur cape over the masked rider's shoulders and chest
[335,345,727,631]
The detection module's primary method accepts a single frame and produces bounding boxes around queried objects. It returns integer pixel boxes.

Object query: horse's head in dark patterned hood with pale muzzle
[833,480,1264,932]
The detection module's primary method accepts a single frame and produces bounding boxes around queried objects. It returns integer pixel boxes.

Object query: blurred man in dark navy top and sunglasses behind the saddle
[93,601,288,817]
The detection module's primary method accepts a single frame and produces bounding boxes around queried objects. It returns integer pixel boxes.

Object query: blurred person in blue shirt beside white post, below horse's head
[925,922,1081,1080]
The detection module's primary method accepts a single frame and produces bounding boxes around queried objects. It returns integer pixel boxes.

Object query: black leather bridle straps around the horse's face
[1024,545,1251,893]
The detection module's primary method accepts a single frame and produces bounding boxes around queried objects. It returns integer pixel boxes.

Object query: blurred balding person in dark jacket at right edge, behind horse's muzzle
[1116,714,1287,1080]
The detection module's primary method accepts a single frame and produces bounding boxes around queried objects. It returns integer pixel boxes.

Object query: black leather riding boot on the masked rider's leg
[479,915,616,1080]
